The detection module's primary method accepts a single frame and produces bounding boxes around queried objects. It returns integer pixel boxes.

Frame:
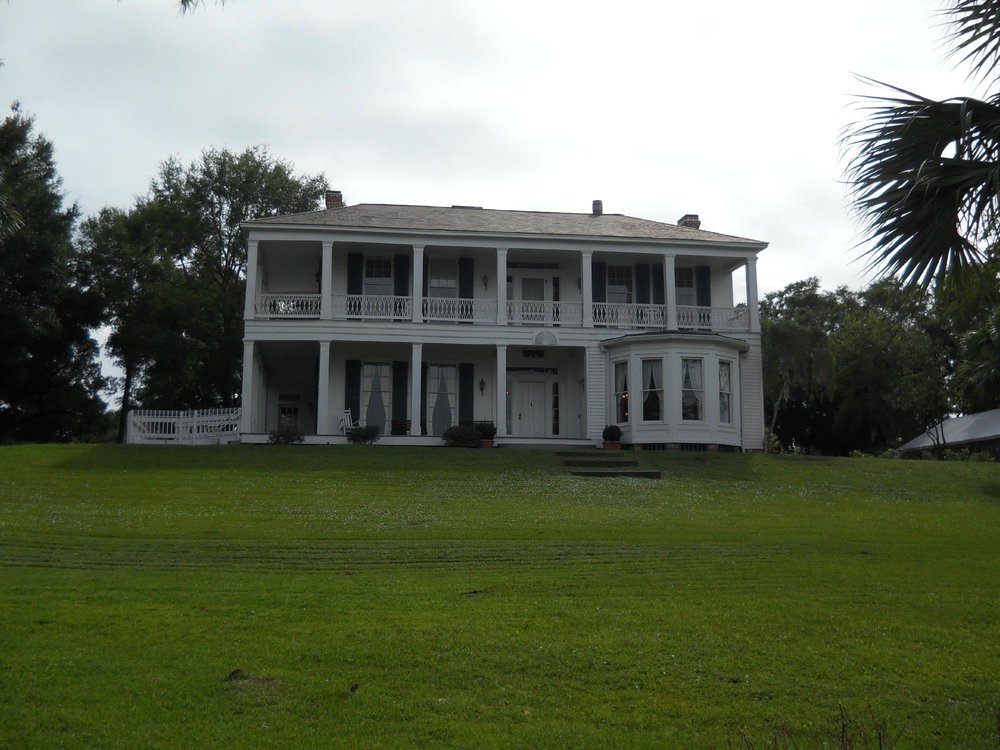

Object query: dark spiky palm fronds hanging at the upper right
[843,0,1000,288]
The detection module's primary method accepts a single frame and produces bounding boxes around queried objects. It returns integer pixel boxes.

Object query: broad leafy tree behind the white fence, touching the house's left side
[98,146,326,408]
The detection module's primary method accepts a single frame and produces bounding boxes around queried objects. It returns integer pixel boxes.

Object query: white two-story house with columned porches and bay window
[241,191,766,450]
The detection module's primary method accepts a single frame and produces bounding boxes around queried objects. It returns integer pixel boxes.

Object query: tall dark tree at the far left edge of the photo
[0,105,104,441]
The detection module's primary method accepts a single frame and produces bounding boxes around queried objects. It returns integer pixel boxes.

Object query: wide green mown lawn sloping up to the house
[0,446,1000,748]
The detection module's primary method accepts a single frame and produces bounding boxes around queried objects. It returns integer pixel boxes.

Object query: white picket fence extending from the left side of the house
[125,407,241,445]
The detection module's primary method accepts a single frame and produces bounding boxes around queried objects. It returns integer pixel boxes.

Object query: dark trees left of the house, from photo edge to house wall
[0,101,326,441]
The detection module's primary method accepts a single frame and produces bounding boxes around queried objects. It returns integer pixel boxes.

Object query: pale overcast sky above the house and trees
[0,0,975,294]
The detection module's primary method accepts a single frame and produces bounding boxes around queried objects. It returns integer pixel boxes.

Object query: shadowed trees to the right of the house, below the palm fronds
[761,274,1000,454]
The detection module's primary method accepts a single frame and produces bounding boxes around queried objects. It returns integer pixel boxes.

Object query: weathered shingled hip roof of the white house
[243,203,767,249]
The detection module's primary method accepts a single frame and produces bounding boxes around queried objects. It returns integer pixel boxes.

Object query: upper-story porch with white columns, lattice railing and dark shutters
[245,236,759,332]
